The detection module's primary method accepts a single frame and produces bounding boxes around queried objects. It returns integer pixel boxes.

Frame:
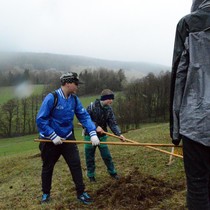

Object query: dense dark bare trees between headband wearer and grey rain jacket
[113,71,170,132]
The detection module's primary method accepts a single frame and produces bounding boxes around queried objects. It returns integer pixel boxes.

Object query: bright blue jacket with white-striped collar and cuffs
[36,88,96,140]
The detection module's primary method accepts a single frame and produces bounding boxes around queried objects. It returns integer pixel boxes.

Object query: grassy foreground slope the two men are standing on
[0,123,186,210]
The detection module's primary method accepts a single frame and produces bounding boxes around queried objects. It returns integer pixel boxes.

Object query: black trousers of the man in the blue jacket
[40,139,85,196]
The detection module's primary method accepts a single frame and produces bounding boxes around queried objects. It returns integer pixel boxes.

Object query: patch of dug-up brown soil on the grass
[94,170,185,210]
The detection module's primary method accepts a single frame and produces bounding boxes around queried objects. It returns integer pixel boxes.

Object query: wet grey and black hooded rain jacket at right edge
[170,0,210,146]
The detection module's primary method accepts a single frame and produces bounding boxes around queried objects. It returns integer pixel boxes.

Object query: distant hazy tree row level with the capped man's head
[0,68,126,95]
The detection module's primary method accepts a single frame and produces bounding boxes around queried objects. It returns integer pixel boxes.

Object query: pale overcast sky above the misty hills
[0,0,192,65]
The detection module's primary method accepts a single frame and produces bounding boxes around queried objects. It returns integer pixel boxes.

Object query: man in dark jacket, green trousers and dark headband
[85,89,125,182]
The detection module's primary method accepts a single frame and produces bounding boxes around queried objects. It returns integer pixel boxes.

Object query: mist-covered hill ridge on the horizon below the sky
[0,52,170,79]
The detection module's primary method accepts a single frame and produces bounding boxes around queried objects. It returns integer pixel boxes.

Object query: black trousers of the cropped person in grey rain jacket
[182,136,210,210]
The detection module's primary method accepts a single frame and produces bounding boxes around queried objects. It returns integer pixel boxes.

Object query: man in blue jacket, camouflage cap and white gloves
[36,72,100,204]
